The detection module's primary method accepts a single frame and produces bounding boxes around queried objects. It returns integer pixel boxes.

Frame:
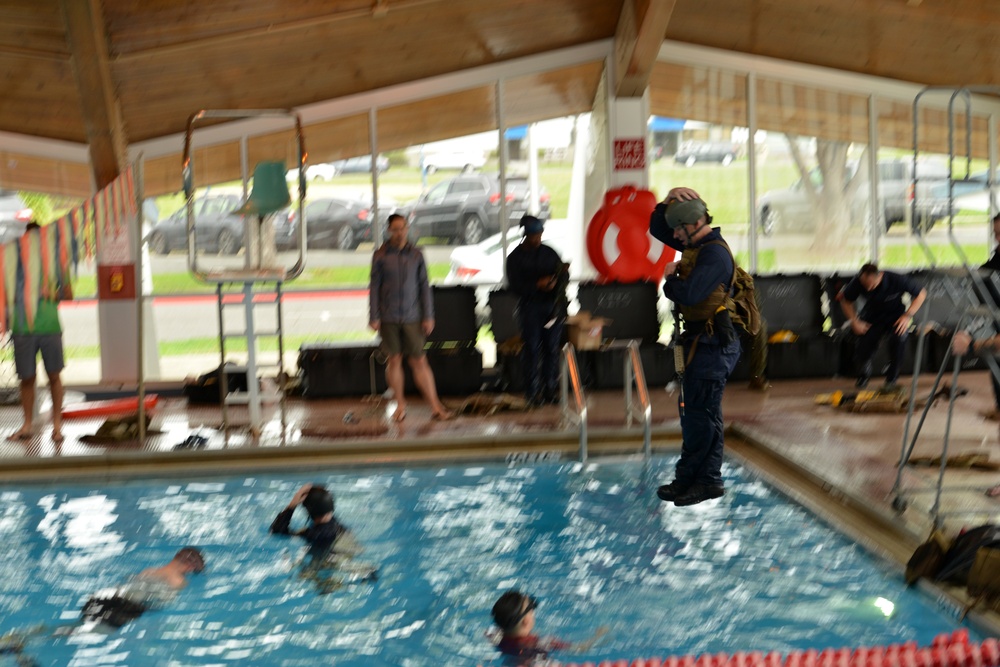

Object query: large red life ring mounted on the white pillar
[587,185,676,283]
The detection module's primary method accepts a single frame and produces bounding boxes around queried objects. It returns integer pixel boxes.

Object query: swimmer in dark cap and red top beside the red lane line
[493,590,608,666]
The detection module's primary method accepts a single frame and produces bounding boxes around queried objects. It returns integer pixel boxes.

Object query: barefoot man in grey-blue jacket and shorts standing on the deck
[368,214,452,422]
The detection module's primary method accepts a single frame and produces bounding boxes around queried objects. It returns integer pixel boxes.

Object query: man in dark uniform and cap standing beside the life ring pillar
[507,215,569,405]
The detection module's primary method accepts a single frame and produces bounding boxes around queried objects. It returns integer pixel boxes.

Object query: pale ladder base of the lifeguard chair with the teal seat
[216,280,287,437]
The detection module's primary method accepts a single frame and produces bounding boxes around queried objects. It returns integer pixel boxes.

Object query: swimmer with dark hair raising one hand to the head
[271,484,378,593]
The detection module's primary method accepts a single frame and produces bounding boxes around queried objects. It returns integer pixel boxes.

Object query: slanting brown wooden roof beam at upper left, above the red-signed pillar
[61,0,128,190]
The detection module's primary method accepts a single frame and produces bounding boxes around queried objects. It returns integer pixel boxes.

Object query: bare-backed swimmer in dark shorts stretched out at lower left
[0,547,205,667]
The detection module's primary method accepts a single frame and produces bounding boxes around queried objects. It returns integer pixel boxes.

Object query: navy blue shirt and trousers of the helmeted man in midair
[649,222,740,486]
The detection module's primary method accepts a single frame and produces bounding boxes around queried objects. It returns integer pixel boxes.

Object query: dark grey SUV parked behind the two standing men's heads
[410,174,550,245]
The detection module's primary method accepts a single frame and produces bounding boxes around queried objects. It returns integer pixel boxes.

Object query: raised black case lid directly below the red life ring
[576,282,660,343]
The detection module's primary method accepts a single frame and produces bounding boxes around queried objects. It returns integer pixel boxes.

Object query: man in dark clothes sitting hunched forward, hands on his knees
[837,263,927,389]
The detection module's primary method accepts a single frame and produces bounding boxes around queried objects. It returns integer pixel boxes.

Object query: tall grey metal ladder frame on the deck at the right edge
[892,86,1000,528]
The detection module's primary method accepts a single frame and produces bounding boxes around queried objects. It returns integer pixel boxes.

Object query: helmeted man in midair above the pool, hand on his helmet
[649,188,740,507]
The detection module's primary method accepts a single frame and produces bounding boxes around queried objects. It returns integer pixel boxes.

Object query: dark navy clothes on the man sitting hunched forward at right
[837,271,920,383]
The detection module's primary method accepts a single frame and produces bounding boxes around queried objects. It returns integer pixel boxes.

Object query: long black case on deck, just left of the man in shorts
[299,343,384,398]
